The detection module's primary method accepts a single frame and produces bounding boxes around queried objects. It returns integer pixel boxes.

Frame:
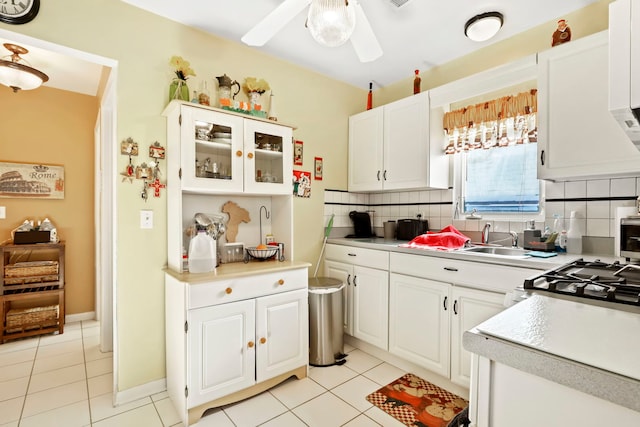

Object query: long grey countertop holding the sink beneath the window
[327,237,621,270]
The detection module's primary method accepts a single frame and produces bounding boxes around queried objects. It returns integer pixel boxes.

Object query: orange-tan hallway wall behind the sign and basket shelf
[0,86,98,314]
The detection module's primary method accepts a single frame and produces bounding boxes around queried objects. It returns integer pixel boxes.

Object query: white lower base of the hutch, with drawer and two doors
[166,268,308,425]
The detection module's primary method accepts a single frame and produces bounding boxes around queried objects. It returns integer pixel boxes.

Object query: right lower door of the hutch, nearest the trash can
[256,289,309,382]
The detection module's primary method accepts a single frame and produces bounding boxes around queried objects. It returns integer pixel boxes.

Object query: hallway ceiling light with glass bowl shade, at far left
[0,43,49,92]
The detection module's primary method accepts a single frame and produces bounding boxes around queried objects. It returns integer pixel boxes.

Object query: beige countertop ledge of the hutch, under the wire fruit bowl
[164,260,311,283]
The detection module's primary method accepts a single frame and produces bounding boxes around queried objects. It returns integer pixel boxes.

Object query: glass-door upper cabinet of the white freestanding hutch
[164,101,293,195]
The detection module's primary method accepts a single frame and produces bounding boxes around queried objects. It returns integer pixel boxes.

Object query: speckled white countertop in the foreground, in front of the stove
[463,295,640,412]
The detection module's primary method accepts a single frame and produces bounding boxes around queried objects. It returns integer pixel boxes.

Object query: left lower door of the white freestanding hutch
[187,300,256,407]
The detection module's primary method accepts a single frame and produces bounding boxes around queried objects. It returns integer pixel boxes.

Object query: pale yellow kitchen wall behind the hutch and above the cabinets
[0,0,608,390]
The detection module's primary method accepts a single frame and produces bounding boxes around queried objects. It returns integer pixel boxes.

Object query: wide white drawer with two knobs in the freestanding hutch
[187,268,308,310]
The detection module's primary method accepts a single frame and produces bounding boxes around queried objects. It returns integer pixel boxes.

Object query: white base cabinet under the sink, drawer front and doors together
[389,253,535,388]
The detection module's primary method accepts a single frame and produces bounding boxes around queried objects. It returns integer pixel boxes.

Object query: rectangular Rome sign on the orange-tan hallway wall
[0,162,64,199]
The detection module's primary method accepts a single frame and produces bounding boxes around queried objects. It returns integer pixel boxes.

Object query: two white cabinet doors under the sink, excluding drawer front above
[389,273,504,387]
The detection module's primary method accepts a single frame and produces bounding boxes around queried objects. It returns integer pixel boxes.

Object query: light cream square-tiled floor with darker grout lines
[0,321,405,427]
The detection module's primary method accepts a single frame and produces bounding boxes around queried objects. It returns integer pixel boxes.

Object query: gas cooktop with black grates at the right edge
[515,259,640,313]
